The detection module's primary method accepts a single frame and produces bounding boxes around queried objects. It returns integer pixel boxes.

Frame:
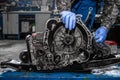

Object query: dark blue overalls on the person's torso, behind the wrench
[71,0,97,28]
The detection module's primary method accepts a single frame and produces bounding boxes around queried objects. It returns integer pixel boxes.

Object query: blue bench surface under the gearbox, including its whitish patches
[0,64,120,80]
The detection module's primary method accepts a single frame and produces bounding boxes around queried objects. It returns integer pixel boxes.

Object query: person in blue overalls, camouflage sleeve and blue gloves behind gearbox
[61,0,120,43]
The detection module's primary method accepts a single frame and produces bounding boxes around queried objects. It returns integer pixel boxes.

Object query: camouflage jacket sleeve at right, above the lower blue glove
[101,0,120,29]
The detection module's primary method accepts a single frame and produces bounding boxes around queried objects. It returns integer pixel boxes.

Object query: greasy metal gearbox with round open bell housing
[21,18,109,70]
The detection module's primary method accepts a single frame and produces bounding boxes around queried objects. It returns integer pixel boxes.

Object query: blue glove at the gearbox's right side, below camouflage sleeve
[95,26,108,43]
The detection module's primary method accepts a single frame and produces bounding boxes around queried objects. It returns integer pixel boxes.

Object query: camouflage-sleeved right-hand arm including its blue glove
[95,0,120,43]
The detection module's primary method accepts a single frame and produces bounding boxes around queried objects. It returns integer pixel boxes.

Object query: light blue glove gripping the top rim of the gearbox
[60,11,76,30]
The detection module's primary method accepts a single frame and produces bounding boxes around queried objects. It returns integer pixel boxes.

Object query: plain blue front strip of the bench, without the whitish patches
[0,72,120,80]
